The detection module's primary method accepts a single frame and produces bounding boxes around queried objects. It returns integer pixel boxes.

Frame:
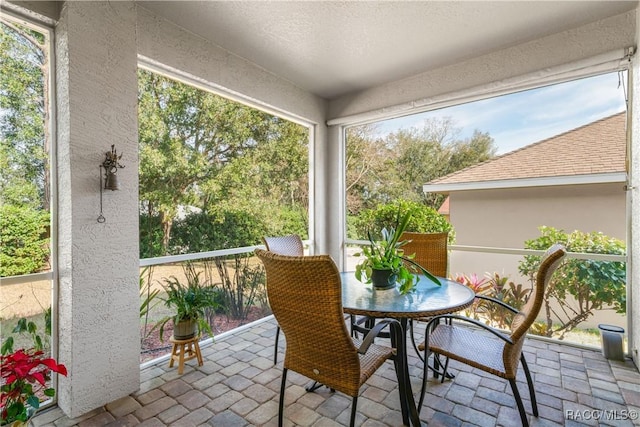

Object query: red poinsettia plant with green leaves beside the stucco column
[0,319,67,425]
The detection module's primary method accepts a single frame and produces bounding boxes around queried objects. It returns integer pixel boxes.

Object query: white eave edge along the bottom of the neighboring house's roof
[422,172,627,193]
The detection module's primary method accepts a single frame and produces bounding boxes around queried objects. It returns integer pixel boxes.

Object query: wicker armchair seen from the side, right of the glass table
[418,244,565,426]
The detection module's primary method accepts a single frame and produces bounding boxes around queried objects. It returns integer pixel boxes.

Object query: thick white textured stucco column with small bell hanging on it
[56,2,140,418]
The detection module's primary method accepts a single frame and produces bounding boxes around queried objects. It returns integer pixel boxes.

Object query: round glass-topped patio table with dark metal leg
[340,272,475,426]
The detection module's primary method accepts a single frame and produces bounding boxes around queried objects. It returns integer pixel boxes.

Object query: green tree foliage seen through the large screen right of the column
[139,70,308,256]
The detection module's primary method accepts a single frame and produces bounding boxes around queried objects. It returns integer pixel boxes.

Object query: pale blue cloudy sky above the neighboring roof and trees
[378,72,627,154]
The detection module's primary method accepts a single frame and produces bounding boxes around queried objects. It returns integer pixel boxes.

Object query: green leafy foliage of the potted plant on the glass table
[355,208,440,295]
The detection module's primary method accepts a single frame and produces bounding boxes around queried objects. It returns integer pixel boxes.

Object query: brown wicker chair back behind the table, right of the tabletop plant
[400,232,449,277]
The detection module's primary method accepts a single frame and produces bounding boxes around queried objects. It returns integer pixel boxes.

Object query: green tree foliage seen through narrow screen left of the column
[0,17,50,276]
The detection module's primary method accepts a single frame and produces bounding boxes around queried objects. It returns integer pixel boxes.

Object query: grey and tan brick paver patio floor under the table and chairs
[33,318,640,427]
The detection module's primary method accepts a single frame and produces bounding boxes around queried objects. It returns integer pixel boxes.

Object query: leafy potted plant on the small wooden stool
[156,266,218,340]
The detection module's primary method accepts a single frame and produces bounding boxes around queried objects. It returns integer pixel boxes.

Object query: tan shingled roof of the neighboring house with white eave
[423,112,626,192]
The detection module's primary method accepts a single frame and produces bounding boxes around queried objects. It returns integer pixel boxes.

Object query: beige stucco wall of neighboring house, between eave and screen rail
[449,183,626,249]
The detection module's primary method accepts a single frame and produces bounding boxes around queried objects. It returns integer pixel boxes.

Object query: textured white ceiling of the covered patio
[138,0,638,99]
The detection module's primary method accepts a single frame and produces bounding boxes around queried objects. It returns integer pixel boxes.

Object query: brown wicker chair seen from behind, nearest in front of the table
[255,249,407,426]
